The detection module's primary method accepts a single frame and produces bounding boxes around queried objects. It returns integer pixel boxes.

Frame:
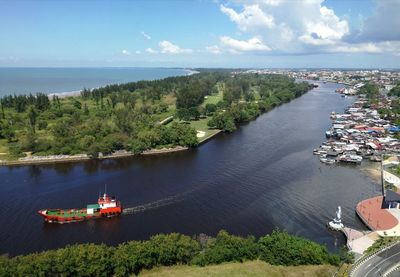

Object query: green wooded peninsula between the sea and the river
[0,71,310,160]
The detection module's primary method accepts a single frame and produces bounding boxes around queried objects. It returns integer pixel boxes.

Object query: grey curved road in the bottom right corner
[352,243,400,277]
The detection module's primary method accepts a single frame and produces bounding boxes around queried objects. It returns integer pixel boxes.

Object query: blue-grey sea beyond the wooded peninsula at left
[0,67,193,97]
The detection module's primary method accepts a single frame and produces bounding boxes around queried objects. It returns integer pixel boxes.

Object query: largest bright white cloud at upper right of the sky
[220,0,349,54]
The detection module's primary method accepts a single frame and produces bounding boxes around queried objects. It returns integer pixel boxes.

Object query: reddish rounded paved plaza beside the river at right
[356,196,399,231]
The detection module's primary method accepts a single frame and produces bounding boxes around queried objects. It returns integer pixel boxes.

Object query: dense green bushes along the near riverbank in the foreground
[0,230,352,276]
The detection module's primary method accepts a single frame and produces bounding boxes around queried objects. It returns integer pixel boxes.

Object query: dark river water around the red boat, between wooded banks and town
[0,83,379,255]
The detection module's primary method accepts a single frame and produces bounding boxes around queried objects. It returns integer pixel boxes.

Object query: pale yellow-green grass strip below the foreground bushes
[139,261,336,277]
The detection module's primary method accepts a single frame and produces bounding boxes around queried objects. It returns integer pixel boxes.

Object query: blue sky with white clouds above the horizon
[0,0,400,68]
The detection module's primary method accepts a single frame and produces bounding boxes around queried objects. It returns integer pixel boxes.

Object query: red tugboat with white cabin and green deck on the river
[38,193,122,223]
